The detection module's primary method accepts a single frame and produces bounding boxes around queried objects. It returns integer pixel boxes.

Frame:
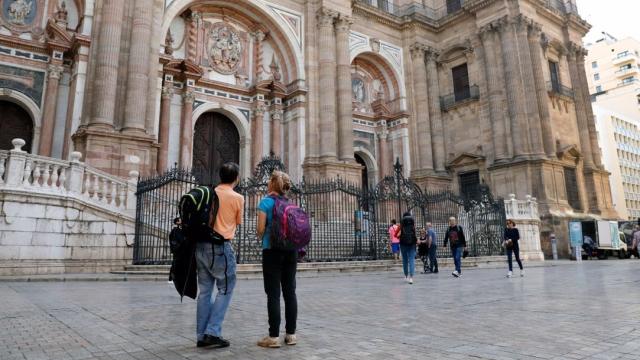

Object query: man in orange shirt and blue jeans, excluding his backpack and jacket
[196,163,244,348]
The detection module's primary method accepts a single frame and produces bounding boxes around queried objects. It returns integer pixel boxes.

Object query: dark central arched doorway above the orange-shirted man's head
[193,112,240,185]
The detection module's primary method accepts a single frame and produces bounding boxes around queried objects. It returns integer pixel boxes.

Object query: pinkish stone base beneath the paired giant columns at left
[72,126,160,177]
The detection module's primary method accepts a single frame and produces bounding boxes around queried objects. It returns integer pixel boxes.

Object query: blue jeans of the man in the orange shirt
[196,241,236,341]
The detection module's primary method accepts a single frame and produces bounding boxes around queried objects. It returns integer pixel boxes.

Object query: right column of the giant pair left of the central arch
[123,0,153,132]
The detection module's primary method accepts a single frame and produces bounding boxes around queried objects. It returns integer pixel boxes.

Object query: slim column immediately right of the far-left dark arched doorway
[38,64,63,156]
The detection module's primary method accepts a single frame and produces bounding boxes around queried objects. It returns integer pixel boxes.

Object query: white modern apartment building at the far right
[585,34,640,219]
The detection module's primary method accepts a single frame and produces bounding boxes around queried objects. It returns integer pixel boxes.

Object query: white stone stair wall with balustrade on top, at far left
[0,139,138,275]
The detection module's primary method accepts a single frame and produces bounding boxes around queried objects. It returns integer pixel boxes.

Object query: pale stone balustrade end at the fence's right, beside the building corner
[504,194,544,261]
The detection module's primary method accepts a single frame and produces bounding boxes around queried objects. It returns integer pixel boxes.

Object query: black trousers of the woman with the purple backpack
[262,250,298,337]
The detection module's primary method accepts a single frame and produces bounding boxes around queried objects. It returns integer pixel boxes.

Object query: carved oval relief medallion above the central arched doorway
[208,23,242,75]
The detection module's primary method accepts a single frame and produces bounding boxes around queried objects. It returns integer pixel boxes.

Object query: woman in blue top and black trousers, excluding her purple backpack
[257,171,298,348]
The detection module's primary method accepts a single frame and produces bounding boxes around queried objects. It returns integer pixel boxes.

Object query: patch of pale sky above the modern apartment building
[576,0,640,43]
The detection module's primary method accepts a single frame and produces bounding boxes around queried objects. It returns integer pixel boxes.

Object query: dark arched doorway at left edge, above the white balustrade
[0,100,33,152]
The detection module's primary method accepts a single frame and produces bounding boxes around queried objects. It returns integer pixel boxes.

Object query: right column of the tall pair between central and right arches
[335,15,354,161]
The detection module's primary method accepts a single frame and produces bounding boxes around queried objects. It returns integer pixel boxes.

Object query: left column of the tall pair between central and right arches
[318,8,338,159]
